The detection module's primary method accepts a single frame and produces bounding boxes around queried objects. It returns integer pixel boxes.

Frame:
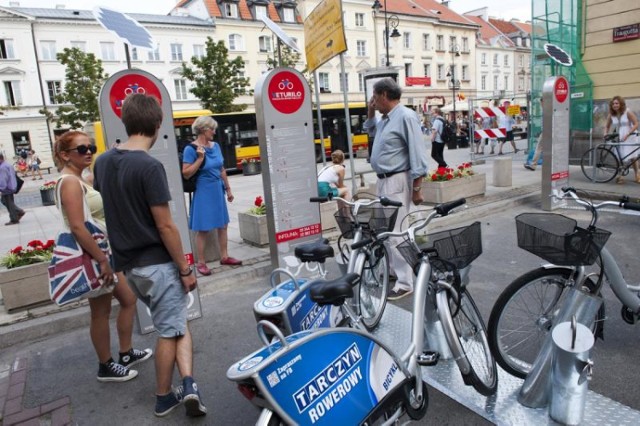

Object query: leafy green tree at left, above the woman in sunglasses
[41,47,109,128]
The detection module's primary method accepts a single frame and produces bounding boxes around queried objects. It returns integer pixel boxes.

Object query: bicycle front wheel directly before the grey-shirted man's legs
[358,243,389,331]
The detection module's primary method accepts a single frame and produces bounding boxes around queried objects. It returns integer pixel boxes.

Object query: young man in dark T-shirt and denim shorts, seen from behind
[94,94,207,417]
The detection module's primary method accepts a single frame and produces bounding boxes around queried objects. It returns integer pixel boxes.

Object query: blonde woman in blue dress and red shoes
[182,116,242,275]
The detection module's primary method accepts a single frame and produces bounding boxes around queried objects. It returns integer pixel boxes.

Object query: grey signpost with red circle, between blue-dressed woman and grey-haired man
[255,68,321,269]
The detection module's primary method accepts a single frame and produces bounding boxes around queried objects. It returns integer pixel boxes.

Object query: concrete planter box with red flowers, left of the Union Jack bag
[0,262,52,311]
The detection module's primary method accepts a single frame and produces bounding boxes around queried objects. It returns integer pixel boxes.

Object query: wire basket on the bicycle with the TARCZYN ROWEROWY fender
[397,222,482,270]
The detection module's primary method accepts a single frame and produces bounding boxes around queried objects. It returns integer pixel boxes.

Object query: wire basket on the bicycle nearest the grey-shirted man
[334,206,398,240]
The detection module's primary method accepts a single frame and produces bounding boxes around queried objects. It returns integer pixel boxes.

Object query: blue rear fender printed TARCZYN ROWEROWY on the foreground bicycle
[227,329,408,426]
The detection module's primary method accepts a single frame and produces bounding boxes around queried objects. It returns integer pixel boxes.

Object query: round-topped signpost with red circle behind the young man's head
[100,70,202,332]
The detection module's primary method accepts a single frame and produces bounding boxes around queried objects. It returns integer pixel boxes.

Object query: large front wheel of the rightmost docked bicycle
[489,268,603,379]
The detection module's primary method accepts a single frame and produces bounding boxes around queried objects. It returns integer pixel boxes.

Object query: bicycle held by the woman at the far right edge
[580,132,640,183]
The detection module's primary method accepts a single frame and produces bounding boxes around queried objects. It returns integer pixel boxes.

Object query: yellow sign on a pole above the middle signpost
[304,0,347,72]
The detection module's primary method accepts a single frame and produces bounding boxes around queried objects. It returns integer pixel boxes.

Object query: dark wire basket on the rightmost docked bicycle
[516,213,611,266]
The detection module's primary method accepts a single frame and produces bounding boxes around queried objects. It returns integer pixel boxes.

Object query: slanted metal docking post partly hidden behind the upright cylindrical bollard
[518,287,602,408]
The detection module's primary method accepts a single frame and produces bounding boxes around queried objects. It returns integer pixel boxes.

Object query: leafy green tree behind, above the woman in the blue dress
[181,37,249,113]
